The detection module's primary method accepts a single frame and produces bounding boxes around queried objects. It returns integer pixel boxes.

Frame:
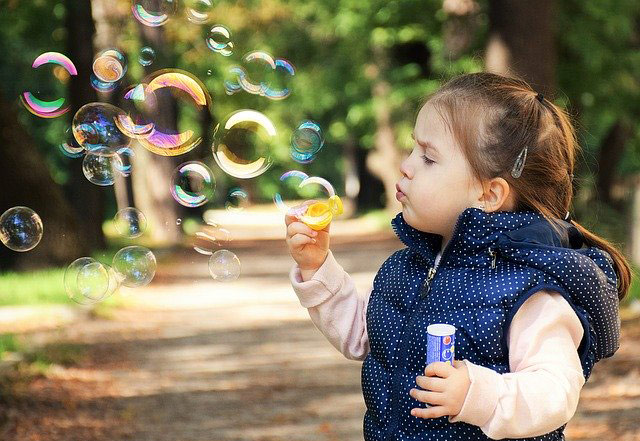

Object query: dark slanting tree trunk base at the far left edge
[0,94,89,270]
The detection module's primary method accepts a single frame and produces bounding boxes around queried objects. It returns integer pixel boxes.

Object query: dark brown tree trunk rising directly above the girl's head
[485,0,556,96]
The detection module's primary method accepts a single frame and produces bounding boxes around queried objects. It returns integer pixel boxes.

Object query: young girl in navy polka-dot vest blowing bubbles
[285,73,631,441]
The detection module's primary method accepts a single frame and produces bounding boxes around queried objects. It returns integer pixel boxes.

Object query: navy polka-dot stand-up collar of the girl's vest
[391,207,583,265]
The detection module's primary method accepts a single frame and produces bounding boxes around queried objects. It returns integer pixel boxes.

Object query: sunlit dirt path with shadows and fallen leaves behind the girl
[0,240,640,441]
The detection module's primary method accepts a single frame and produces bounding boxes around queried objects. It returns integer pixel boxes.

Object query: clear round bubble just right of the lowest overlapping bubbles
[113,246,157,288]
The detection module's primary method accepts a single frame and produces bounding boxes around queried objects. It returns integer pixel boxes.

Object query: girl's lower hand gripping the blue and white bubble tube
[409,360,471,418]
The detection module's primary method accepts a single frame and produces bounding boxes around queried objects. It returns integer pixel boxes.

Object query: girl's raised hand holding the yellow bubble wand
[284,201,331,272]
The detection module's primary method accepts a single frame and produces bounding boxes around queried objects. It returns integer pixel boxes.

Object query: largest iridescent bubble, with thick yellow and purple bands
[132,69,211,156]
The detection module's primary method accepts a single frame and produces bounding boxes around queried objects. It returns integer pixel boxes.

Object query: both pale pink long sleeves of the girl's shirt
[289,251,585,439]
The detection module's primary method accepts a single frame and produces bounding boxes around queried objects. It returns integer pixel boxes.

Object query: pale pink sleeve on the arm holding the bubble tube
[449,291,585,439]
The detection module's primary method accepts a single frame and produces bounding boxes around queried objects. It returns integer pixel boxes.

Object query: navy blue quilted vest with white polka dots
[362,208,620,441]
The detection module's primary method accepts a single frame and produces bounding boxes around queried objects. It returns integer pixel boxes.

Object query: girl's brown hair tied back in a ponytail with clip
[428,72,631,301]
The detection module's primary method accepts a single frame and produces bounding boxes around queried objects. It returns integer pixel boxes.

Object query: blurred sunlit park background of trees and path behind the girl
[0,0,640,441]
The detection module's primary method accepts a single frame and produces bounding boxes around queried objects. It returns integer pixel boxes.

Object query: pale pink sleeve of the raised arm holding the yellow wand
[289,251,371,360]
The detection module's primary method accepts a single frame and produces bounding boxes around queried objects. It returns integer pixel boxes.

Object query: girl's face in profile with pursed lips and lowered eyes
[396,103,483,246]
